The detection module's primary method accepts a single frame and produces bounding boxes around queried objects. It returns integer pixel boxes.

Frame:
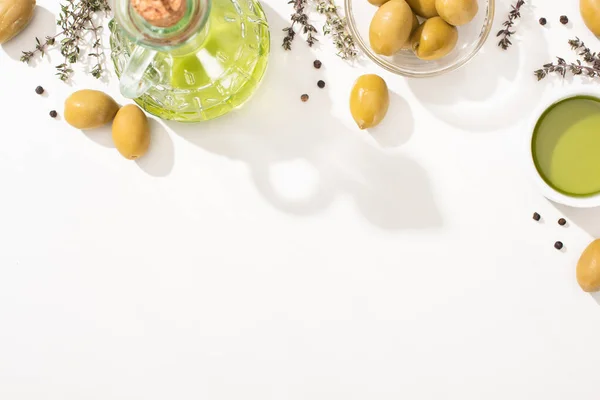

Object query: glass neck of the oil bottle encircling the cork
[115,0,211,51]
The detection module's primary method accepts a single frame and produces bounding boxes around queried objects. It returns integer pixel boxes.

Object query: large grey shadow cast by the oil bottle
[162,4,442,229]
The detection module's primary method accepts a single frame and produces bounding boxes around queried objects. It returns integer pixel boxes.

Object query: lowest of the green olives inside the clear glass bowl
[411,17,458,60]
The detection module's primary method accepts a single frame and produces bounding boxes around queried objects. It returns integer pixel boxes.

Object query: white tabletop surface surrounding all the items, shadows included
[0,0,600,400]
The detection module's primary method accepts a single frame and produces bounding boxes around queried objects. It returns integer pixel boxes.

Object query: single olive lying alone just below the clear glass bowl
[350,74,394,129]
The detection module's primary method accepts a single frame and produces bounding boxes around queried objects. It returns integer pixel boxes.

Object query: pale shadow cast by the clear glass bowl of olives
[407,5,549,132]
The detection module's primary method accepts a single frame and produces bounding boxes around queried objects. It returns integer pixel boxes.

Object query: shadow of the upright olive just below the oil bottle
[136,118,175,177]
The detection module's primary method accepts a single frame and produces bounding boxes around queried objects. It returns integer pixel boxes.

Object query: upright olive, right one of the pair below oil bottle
[113,104,150,160]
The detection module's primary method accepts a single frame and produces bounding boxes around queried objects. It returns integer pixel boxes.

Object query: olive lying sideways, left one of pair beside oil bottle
[64,89,119,129]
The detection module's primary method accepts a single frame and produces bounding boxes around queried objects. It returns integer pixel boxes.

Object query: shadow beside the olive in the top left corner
[2,5,56,67]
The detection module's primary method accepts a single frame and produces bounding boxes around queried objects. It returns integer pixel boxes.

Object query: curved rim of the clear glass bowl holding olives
[344,0,496,78]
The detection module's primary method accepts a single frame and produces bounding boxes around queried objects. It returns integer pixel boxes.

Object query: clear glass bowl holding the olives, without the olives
[344,0,495,78]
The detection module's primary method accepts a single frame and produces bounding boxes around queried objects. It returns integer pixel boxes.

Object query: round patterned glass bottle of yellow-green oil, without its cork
[109,0,270,122]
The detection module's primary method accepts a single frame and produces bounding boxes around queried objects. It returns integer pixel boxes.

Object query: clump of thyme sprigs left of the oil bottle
[21,0,110,81]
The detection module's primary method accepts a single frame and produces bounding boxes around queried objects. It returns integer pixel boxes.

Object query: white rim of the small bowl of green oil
[524,87,600,208]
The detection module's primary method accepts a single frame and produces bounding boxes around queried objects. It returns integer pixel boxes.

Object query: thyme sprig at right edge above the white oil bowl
[533,38,600,81]
